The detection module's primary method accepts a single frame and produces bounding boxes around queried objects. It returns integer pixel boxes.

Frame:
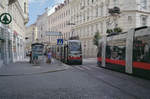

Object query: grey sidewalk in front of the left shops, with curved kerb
[0,60,69,76]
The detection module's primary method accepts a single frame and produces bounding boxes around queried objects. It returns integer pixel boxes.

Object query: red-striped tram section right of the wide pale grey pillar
[132,33,150,79]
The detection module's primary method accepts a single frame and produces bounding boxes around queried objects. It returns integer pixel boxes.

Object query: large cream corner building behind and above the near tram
[70,0,150,57]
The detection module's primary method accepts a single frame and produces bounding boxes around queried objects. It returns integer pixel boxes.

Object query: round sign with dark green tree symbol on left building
[0,13,12,24]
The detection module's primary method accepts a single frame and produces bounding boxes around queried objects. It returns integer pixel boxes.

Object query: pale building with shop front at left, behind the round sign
[0,0,29,65]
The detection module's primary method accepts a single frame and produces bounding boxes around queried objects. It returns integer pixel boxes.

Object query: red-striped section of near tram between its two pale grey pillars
[105,39,126,72]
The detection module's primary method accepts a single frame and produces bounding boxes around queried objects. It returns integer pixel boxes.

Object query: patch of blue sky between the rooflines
[27,0,64,26]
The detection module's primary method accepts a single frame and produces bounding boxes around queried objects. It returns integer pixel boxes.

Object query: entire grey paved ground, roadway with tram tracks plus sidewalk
[0,59,150,99]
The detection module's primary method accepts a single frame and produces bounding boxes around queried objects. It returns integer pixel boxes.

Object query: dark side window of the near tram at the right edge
[133,36,150,63]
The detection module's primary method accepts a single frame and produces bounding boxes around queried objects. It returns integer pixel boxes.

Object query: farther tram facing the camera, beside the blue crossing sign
[52,40,82,65]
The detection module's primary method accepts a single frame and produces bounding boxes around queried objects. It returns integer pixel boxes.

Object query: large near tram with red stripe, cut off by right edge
[97,26,150,79]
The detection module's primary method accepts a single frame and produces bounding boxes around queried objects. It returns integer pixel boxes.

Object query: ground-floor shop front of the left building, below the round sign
[0,26,25,67]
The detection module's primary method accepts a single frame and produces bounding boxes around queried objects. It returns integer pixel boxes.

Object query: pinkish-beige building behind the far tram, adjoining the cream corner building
[48,0,71,45]
